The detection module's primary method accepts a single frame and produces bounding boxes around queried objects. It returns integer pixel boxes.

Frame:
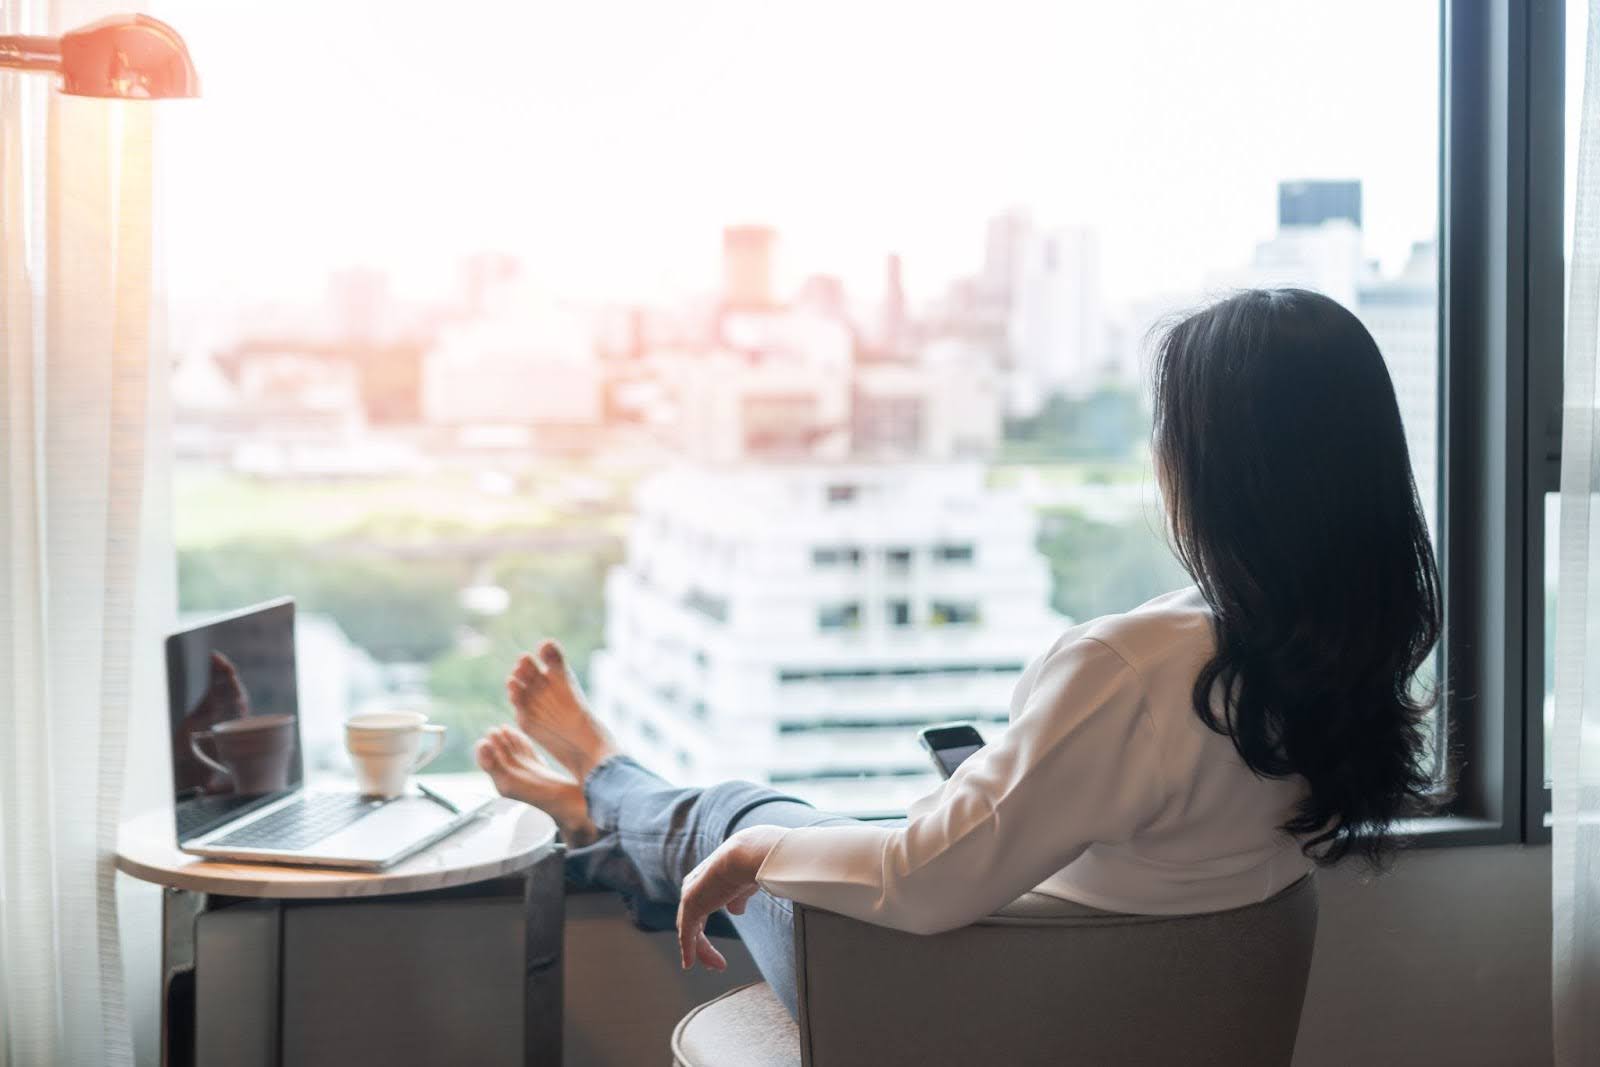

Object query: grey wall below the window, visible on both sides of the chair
[566,846,1550,1067]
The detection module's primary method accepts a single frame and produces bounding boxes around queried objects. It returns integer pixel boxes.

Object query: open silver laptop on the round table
[166,598,493,870]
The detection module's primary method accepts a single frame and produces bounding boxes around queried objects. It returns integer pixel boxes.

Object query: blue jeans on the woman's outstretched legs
[566,755,854,1014]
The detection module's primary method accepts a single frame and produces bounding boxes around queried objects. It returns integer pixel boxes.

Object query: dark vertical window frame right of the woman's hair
[1427,0,1566,846]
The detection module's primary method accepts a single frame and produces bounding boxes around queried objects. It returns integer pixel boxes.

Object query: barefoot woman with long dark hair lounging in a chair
[478,290,1440,1011]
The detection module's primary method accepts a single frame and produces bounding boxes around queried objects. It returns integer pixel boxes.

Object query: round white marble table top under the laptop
[117,783,555,899]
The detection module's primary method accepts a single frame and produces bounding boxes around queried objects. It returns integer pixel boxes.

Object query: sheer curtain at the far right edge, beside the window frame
[1550,0,1600,1067]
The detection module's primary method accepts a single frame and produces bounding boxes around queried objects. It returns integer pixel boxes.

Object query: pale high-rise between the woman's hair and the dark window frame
[1354,242,1438,531]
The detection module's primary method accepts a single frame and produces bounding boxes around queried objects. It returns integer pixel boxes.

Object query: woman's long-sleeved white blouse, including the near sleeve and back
[757,589,1310,933]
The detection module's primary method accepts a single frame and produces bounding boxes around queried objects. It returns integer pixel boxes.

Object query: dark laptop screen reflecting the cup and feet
[166,600,301,843]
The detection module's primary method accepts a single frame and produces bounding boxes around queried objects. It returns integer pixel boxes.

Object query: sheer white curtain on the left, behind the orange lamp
[0,0,158,1067]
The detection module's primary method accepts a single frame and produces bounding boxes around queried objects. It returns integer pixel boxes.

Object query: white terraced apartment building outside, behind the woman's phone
[590,462,1066,811]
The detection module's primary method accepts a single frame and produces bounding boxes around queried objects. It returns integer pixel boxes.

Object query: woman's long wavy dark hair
[1154,290,1442,867]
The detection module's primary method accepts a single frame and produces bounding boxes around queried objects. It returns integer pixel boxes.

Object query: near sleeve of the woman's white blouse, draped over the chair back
[757,638,1165,933]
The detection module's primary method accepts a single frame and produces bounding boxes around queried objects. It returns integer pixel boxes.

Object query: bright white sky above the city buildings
[152,0,1438,315]
